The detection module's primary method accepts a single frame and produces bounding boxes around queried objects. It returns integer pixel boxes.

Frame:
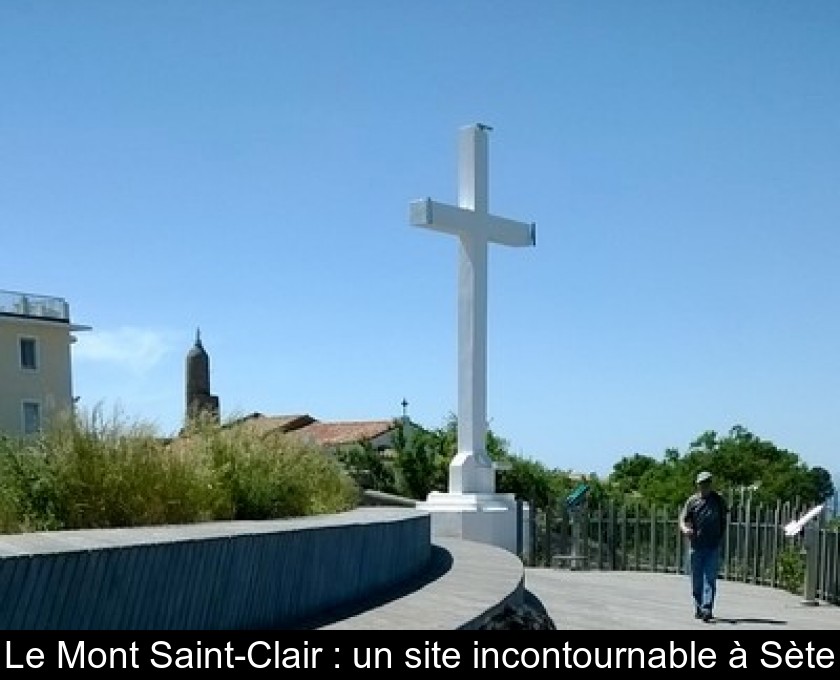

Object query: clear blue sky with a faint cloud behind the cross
[0,0,840,476]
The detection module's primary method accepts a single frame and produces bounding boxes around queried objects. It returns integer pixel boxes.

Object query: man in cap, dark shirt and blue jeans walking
[680,472,729,621]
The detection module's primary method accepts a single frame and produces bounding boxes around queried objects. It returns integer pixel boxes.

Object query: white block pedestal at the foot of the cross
[416,491,527,555]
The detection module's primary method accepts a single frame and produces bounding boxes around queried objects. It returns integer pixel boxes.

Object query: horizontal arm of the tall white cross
[409,198,537,246]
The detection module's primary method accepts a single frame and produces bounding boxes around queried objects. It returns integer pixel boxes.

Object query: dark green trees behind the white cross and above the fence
[342,416,835,508]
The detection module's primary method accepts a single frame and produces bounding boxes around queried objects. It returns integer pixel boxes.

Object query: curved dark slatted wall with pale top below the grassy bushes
[0,508,432,630]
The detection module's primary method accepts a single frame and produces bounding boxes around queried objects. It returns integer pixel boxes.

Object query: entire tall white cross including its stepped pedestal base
[410,124,536,552]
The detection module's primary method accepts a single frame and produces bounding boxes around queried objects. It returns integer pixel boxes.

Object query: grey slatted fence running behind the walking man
[529,503,840,604]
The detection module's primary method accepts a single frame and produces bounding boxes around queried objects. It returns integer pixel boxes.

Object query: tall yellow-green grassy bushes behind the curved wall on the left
[0,409,358,533]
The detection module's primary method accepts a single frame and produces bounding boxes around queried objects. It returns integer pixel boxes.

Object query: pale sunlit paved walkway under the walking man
[525,568,840,630]
